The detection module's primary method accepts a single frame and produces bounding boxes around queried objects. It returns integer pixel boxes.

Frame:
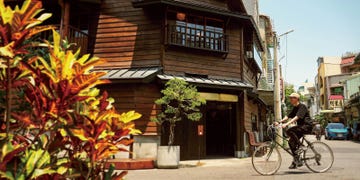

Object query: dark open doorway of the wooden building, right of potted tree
[205,102,236,156]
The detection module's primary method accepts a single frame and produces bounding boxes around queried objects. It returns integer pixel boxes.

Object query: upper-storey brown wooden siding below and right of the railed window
[163,23,242,80]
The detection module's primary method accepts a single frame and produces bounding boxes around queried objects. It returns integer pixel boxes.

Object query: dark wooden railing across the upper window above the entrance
[167,25,228,53]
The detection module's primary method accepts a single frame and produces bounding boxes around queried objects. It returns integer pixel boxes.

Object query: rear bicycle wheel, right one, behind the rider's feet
[304,142,334,173]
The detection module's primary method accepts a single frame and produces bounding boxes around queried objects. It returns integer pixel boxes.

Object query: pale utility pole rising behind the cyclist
[273,32,283,145]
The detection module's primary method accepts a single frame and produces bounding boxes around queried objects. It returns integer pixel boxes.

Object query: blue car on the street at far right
[325,123,349,140]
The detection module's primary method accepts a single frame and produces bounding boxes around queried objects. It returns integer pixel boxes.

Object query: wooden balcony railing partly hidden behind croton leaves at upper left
[40,25,89,54]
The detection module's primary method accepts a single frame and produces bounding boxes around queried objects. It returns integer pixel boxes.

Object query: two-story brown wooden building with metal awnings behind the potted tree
[4,0,266,159]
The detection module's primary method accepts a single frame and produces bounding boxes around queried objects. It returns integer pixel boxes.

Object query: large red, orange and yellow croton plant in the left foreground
[0,0,141,180]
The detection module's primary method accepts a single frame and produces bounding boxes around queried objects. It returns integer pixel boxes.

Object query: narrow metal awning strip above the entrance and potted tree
[157,74,254,89]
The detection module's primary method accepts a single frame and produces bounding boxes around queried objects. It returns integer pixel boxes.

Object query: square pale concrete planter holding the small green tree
[156,146,180,169]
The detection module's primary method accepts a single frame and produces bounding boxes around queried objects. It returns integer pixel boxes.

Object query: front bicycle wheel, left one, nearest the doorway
[251,144,281,175]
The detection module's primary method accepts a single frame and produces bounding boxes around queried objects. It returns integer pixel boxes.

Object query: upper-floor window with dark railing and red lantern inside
[167,11,228,52]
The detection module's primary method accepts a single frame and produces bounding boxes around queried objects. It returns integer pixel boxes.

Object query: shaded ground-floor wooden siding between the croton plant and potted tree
[101,84,160,135]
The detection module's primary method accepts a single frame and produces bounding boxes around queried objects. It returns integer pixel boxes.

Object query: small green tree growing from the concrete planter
[152,78,206,146]
